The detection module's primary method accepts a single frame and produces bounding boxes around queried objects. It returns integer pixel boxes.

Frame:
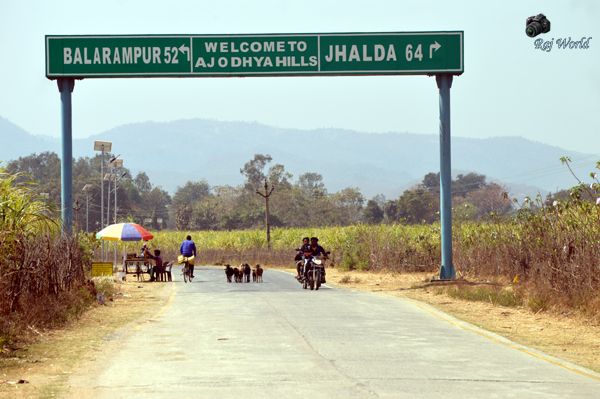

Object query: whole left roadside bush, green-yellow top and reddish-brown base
[0,168,94,343]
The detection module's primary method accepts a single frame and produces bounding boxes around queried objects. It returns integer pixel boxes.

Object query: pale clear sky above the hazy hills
[0,0,600,156]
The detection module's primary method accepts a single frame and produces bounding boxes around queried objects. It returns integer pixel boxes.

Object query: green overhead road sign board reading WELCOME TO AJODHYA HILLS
[46,31,464,79]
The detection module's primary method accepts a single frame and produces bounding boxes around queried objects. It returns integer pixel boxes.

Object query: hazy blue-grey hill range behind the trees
[0,118,600,198]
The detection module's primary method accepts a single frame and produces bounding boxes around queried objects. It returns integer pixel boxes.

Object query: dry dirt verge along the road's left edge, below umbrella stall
[0,282,176,398]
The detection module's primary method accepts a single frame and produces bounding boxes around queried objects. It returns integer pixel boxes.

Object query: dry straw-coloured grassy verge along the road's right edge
[327,268,600,372]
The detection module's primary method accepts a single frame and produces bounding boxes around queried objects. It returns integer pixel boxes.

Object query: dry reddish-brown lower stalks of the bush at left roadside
[0,235,94,339]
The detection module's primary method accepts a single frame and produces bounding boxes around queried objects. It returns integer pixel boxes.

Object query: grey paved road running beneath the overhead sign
[71,268,600,399]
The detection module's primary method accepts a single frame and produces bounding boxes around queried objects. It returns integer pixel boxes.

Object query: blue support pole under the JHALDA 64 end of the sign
[435,74,456,280]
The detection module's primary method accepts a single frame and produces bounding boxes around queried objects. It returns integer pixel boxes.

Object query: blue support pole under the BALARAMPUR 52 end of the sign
[56,78,75,235]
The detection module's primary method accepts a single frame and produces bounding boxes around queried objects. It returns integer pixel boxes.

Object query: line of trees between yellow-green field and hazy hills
[6,152,512,231]
